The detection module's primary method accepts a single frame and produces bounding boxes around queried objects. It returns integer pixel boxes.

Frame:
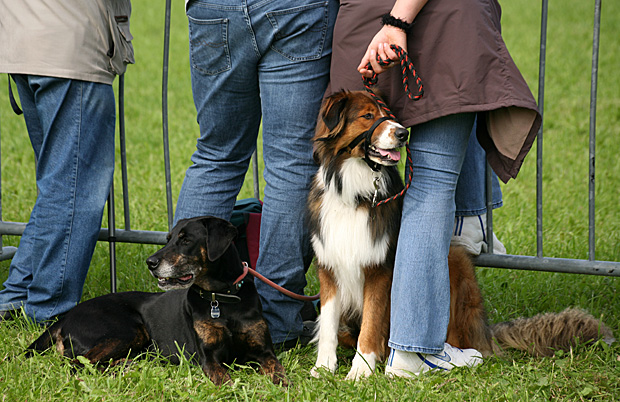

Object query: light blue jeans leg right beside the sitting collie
[389,113,475,353]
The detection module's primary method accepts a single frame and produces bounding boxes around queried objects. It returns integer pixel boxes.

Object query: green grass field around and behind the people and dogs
[0,0,620,401]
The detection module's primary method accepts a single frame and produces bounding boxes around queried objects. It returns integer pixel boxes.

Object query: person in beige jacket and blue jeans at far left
[0,0,133,323]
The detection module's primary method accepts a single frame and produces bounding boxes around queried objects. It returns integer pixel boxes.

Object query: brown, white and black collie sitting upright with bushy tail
[308,91,611,379]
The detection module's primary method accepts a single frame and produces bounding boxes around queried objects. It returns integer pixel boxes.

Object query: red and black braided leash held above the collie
[362,45,424,207]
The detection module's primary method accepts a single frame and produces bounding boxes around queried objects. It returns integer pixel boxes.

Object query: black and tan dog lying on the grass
[28,217,287,385]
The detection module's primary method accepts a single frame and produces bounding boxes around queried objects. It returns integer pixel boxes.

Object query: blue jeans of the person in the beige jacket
[0,75,115,322]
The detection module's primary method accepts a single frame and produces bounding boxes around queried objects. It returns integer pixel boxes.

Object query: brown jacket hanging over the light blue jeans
[328,0,542,182]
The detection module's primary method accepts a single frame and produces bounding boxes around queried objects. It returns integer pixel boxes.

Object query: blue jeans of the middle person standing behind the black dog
[175,0,338,342]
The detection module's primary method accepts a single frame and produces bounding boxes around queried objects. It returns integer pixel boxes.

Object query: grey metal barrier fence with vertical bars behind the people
[0,0,620,292]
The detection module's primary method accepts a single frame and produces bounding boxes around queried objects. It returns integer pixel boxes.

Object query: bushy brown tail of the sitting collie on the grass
[491,308,615,356]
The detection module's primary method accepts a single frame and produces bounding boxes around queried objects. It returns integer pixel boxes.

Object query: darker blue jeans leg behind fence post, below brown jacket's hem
[455,117,502,216]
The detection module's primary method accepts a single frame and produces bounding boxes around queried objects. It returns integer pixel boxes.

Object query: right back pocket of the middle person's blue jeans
[266,1,329,61]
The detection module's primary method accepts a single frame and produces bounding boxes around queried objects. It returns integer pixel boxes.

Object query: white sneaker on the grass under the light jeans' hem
[385,343,482,377]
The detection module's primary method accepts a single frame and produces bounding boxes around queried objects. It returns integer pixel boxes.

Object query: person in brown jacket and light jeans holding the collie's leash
[330,0,542,376]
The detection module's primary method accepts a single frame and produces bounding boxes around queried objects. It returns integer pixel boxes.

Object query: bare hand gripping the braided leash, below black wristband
[357,25,407,78]
